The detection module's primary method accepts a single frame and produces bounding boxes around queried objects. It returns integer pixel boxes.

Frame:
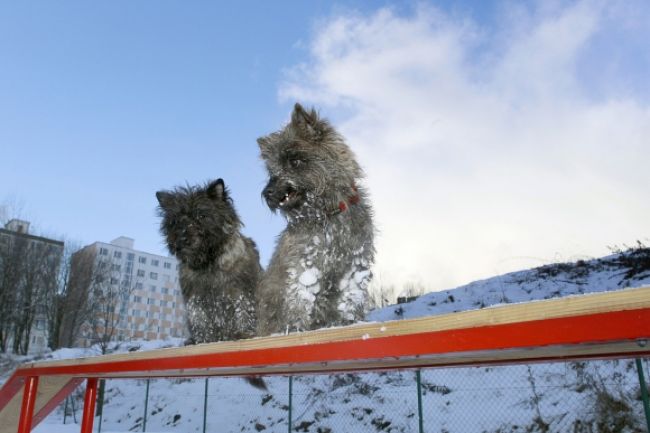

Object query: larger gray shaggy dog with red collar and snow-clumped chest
[257,104,375,335]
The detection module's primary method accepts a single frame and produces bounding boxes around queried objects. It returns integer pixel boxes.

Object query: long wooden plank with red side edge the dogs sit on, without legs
[11,287,650,377]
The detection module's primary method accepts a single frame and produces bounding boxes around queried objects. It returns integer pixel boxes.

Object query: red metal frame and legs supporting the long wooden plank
[0,288,650,433]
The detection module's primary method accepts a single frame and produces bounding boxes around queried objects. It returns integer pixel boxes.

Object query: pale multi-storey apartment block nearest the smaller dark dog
[73,236,187,345]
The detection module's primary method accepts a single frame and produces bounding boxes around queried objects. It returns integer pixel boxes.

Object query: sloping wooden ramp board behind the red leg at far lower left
[0,376,72,433]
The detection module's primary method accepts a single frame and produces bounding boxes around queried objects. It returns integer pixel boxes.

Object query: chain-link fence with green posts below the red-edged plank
[43,359,649,433]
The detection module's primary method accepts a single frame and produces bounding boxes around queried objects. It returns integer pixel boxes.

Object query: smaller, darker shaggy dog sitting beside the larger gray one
[156,179,262,343]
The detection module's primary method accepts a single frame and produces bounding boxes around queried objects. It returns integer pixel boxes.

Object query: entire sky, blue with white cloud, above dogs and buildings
[0,0,650,290]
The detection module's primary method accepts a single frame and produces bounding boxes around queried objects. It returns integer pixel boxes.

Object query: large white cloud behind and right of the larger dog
[281,2,650,290]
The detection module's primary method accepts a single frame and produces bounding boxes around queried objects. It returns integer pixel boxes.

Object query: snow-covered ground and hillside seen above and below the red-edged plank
[5,248,650,433]
